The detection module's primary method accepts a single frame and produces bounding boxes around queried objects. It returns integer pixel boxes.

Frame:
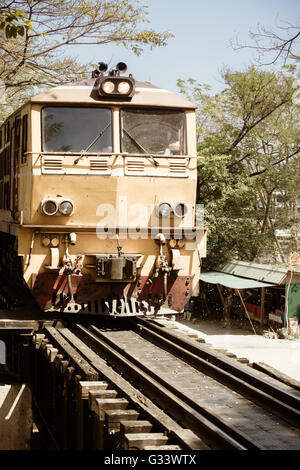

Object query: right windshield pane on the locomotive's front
[121,109,185,155]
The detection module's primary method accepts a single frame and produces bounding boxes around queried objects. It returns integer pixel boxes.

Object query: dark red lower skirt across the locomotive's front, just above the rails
[32,272,192,316]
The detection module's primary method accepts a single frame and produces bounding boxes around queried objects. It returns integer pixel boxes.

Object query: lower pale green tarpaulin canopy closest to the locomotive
[200,271,275,289]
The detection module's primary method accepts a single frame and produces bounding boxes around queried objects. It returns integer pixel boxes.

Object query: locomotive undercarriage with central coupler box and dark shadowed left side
[0,230,193,316]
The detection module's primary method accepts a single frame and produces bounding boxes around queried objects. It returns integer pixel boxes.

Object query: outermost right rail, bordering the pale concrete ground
[134,317,300,411]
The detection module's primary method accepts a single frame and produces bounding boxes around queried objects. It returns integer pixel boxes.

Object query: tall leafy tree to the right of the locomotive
[178,67,300,264]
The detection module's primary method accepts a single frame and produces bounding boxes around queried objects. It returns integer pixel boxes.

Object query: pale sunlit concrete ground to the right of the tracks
[170,320,300,384]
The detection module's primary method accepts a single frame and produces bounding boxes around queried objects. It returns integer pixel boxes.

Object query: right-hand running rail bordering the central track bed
[132,320,300,428]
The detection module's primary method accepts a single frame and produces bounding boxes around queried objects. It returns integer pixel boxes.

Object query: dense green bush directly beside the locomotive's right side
[197,151,263,269]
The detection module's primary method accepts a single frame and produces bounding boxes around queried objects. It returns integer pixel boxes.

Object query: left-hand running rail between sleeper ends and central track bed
[75,324,264,450]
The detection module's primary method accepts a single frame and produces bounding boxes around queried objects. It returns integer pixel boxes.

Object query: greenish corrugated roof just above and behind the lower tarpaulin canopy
[216,260,300,284]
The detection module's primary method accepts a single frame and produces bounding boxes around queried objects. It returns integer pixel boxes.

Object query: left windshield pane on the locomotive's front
[42,106,112,153]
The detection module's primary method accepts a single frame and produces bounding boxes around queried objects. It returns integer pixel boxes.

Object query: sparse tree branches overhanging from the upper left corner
[0,0,172,121]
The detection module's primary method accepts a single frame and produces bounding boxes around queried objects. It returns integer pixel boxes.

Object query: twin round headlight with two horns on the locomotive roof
[92,62,135,99]
